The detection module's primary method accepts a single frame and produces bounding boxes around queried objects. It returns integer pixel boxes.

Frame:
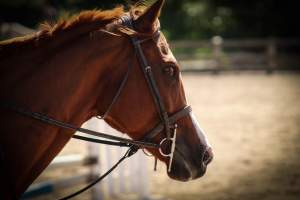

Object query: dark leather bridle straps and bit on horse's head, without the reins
[102,15,192,172]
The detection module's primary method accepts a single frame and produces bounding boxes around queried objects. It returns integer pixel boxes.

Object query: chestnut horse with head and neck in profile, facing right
[0,0,213,199]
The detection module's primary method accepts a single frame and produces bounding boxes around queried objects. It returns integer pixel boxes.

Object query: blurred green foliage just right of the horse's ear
[161,0,235,39]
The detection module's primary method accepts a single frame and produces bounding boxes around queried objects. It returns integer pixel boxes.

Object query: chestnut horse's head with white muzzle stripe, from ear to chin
[99,0,213,181]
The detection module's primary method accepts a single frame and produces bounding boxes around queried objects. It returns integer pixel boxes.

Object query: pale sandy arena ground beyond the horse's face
[29,73,300,200]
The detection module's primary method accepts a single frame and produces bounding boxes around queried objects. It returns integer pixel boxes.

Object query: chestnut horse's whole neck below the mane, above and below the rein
[0,29,130,198]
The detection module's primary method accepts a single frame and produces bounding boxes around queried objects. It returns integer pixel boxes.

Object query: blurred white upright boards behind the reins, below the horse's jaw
[98,121,149,199]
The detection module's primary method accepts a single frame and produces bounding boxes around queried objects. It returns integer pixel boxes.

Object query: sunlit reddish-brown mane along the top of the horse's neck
[0,6,124,56]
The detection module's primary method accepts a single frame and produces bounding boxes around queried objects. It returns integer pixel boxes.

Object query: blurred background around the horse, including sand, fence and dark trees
[0,0,300,200]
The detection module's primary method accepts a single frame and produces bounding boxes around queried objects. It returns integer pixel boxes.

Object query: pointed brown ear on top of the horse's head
[134,0,164,32]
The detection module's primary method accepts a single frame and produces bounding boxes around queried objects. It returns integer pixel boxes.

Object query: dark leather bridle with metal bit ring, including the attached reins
[0,15,191,199]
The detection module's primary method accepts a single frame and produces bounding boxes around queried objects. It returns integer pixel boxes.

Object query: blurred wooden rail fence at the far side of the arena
[170,36,300,72]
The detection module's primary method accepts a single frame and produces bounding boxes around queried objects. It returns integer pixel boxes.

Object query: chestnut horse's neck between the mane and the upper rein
[0,33,128,125]
